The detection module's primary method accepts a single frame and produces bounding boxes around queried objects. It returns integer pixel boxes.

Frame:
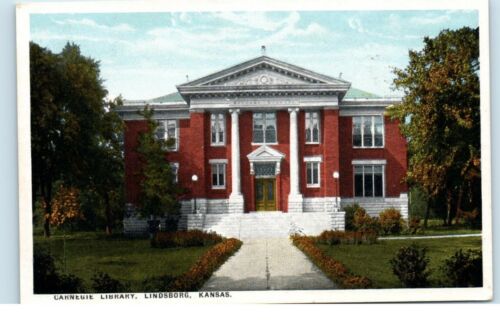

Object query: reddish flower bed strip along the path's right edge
[291,235,371,289]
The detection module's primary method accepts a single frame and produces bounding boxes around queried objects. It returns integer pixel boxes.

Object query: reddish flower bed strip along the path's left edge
[170,238,242,291]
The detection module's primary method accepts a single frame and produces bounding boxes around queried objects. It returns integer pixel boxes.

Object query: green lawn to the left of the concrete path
[34,232,211,292]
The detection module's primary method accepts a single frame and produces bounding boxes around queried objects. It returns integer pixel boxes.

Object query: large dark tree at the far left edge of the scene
[30,42,123,236]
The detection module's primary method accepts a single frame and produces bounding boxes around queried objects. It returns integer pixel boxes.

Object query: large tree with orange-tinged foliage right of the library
[388,27,481,224]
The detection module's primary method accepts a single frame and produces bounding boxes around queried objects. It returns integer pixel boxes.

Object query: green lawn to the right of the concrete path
[318,237,481,288]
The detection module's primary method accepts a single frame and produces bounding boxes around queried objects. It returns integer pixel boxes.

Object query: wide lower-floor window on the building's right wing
[354,165,384,197]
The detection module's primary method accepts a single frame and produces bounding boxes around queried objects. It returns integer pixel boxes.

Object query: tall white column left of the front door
[229,109,244,213]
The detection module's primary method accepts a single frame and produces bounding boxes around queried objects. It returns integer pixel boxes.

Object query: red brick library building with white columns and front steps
[119,56,408,236]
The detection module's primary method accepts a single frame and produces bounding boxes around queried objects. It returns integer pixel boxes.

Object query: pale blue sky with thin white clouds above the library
[30,10,479,100]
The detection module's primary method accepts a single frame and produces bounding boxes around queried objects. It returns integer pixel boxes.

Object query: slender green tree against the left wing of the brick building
[136,106,182,224]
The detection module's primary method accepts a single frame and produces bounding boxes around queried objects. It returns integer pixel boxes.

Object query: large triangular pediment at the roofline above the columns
[180,56,350,87]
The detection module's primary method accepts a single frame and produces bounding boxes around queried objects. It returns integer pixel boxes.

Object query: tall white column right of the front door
[288,108,303,212]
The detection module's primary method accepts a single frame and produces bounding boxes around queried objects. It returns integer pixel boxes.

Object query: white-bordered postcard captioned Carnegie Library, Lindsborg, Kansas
[17,0,493,304]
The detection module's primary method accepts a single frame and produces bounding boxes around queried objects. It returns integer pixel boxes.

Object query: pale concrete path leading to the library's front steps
[201,238,336,291]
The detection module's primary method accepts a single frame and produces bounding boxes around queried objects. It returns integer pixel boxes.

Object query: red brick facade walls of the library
[125,107,407,212]
